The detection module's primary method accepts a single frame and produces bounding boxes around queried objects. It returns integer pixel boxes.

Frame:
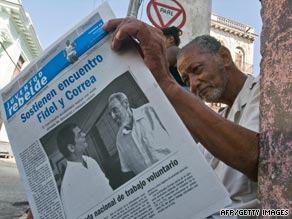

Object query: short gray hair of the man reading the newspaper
[179,35,221,56]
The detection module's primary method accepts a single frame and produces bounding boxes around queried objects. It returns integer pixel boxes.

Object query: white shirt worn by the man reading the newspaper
[201,76,260,219]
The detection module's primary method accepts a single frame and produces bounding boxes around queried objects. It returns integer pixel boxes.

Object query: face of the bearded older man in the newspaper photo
[109,98,129,127]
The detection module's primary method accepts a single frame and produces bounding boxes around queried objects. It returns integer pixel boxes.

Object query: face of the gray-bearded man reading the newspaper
[178,45,228,102]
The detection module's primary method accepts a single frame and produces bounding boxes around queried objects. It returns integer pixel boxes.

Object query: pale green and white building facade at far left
[0,0,42,152]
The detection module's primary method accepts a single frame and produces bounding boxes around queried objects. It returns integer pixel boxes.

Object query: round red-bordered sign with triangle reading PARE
[147,0,186,29]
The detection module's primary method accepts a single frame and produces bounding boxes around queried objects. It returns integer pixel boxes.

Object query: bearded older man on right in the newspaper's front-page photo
[108,92,170,174]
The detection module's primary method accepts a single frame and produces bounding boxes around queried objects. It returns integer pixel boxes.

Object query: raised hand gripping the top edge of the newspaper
[103,18,171,85]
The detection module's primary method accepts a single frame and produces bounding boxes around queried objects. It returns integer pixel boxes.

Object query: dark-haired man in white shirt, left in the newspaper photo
[57,124,113,219]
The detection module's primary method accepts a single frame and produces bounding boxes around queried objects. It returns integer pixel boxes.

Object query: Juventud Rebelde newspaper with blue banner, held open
[0,3,230,219]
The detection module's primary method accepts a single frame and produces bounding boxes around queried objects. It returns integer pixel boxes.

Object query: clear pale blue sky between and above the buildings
[21,0,262,74]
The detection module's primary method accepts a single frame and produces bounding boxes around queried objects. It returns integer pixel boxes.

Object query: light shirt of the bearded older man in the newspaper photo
[116,105,171,174]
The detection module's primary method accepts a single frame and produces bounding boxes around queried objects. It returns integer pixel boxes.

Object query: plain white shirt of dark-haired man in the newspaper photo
[61,156,113,219]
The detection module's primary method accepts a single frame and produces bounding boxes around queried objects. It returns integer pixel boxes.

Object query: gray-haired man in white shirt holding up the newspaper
[103,18,259,218]
